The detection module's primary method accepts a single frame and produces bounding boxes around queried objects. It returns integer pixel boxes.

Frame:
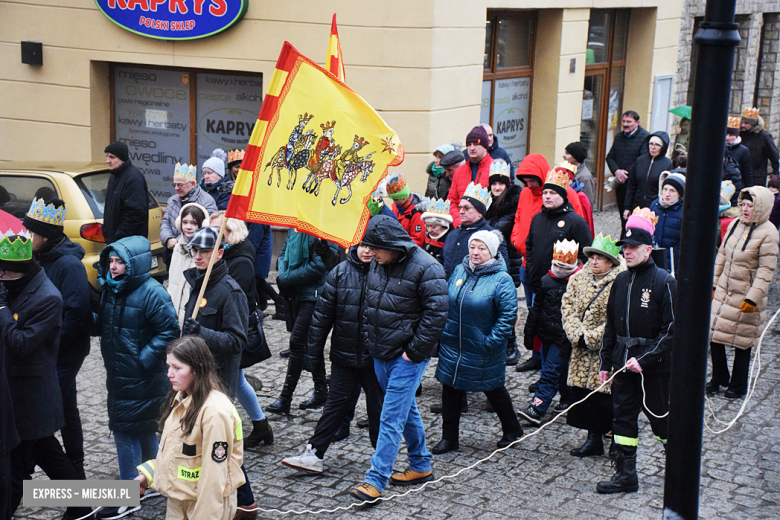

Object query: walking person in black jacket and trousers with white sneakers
[282,245,384,473]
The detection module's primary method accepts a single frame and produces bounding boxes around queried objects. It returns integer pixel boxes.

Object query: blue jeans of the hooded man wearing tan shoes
[365,356,431,492]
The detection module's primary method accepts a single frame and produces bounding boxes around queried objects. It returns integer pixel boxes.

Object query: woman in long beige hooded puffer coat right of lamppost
[707,186,779,398]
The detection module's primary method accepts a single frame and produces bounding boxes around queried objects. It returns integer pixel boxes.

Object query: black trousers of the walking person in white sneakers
[309,363,385,453]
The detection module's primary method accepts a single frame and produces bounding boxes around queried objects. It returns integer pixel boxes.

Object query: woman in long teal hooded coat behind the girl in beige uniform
[95,236,179,494]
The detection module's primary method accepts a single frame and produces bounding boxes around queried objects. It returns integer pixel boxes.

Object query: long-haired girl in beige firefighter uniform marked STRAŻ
[138,336,244,520]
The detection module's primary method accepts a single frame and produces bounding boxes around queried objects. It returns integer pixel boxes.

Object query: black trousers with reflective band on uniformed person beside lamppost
[612,371,671,446]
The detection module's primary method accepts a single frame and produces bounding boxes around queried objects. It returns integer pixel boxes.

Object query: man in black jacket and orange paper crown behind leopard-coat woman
[525,177,593,294]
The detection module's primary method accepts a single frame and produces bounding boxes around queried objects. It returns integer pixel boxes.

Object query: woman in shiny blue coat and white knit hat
[433,231,523,455]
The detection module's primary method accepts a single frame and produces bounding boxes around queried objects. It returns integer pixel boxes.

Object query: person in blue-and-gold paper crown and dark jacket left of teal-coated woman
[24,199,92,478]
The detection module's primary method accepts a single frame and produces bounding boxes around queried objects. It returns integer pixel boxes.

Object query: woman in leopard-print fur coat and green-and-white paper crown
[561,234,626,457]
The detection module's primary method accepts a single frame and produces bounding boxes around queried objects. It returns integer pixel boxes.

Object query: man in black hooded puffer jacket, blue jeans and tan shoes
[351,215,449,500]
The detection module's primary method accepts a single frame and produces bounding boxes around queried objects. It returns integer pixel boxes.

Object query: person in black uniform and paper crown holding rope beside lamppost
[596,208,677,494]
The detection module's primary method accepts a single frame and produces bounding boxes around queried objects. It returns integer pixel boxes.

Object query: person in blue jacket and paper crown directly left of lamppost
[650,172,685,273]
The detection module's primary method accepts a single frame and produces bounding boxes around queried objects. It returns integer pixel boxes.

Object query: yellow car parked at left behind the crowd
[0,163,167,298]
